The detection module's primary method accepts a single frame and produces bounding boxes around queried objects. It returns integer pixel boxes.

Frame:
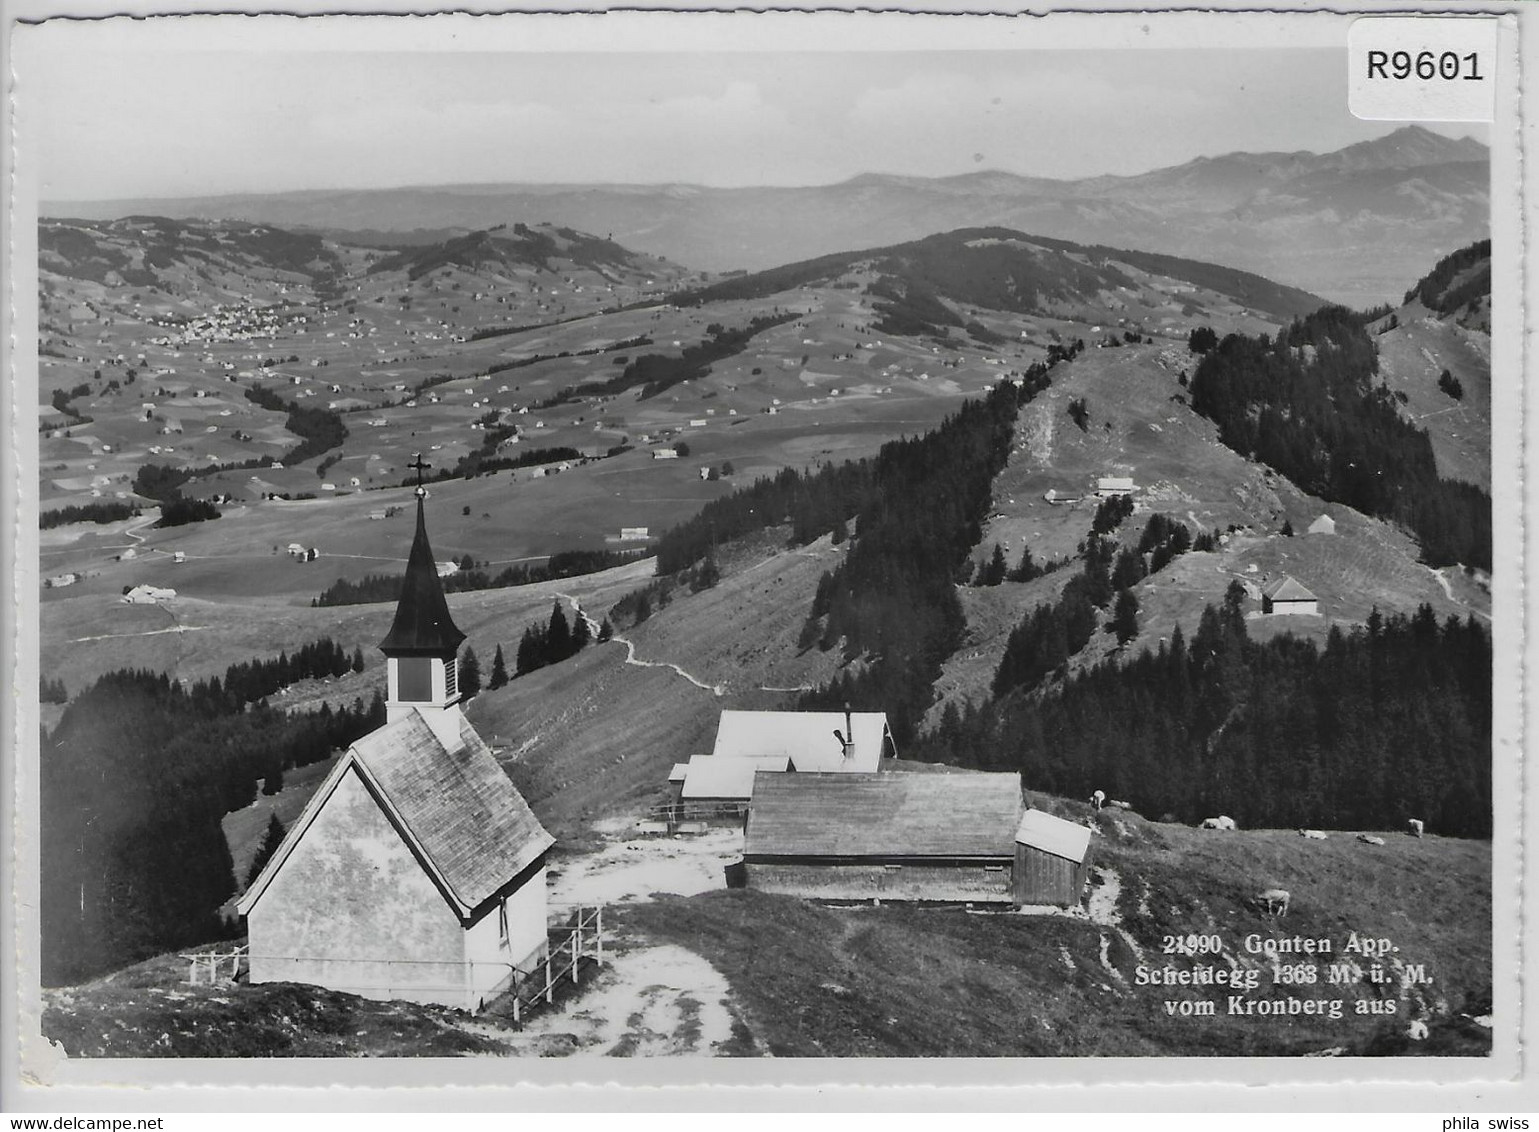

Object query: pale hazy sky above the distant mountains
[17,27,1485,201]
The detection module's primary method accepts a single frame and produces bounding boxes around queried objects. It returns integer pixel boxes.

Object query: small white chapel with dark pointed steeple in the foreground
[237,495,554,1010]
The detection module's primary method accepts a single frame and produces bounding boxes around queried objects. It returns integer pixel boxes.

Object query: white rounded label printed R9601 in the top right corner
[1347,15,1497,122]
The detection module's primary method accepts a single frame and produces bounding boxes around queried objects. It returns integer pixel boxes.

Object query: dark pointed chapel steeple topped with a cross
[380,454,465,746]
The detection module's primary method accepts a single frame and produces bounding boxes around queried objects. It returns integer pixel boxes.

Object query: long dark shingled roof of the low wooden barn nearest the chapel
[743,774,1023,858]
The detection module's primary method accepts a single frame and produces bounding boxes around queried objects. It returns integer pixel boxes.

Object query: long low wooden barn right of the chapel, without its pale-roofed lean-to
[742,772,1023,904]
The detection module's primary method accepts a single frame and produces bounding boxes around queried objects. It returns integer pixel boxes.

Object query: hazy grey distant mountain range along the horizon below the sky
[43,126,1490,306]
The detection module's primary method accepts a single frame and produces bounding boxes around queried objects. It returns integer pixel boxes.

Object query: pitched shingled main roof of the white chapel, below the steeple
[237,712,556,917]
